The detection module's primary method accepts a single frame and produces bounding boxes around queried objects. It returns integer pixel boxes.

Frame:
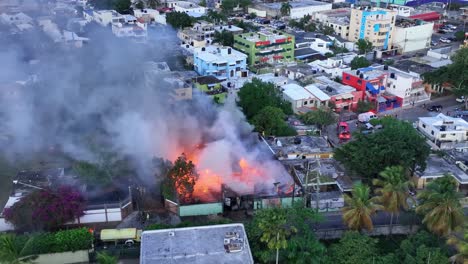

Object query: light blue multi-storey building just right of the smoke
[193,46,248,80]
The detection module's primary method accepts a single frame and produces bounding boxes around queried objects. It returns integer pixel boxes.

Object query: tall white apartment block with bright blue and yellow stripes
[348,7,397,50]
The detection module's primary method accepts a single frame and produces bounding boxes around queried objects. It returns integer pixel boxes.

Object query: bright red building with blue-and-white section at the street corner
[342,67,403,112]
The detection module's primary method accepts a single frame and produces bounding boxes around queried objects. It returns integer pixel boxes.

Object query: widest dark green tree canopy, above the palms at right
[334,117,430,178]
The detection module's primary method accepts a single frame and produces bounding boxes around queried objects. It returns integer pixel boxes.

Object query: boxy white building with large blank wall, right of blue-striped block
[392,18,434,53]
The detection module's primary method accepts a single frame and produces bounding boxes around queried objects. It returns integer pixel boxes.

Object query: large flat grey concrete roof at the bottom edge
[140,224,254,264]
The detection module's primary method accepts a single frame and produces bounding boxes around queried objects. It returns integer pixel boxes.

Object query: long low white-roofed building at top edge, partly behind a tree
[249,0,332,19]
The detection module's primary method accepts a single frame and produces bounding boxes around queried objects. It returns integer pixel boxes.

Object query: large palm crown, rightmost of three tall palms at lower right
[416,174,463,236]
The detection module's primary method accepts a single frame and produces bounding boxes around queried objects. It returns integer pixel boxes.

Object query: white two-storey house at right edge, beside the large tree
[418,113,468,146]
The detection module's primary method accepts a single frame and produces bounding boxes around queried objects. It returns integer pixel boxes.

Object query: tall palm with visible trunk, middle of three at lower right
[372,166,412,235]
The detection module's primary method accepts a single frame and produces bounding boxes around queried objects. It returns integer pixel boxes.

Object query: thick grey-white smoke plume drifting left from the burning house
[0,17,292,198]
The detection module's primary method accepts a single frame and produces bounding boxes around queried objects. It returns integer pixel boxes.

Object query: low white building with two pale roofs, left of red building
[281,83,330,114]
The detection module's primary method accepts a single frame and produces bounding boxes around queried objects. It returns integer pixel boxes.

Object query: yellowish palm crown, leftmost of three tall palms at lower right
[341,183,383,230]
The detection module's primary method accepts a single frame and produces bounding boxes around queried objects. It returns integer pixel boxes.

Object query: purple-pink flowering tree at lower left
[4,186,86,231]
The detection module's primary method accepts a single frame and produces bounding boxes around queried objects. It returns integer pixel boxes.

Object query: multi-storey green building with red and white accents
[234,30,294,66]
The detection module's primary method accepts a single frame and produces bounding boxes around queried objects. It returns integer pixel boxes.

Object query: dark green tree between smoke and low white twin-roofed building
[238,78,293,120]
